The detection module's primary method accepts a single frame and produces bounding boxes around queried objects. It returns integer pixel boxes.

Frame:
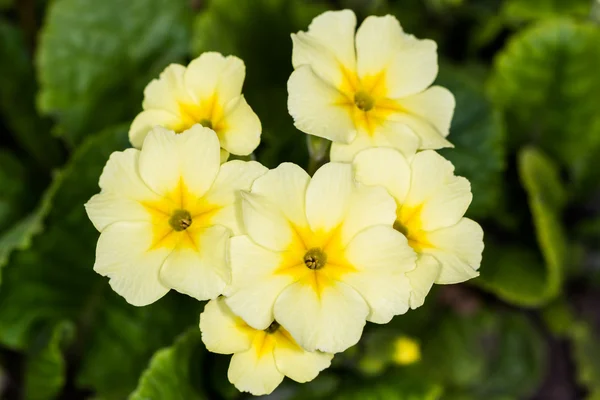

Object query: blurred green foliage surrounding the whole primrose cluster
[0,0,600,400]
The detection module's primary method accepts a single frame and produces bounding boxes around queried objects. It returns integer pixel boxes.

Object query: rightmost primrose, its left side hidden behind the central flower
[353,148,483,308]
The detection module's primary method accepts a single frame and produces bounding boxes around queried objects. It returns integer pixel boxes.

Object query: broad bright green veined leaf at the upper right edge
[489,19,600,195]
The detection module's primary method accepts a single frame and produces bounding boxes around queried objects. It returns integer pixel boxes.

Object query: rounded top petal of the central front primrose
[306,163,356,232]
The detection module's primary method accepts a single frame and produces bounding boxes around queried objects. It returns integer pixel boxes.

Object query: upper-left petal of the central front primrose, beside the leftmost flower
[252,163,310,228]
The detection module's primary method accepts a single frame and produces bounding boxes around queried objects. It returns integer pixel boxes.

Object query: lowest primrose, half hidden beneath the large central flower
[200,297,333,396]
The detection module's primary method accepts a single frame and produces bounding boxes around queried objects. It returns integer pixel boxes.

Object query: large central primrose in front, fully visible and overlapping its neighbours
[225,163,416,353]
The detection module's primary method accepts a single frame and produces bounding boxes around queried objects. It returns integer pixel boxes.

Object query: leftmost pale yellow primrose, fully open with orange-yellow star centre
[85,125,266,306]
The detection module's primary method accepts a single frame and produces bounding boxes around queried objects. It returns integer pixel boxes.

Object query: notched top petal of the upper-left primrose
[184,52,246,104]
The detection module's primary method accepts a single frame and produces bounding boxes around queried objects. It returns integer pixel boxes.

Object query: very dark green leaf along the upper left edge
[0,18,62,169]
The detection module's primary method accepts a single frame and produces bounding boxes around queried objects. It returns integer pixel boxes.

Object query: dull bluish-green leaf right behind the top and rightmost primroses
[437,65,506,222]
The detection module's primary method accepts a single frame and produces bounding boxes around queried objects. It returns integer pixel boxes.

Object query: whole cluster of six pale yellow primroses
[86,10,483,395]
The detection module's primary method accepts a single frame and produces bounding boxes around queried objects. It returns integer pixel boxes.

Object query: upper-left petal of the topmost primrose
[292,10,356,85]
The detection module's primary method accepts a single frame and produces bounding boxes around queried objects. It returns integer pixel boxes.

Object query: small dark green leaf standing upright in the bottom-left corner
[24,321,75,400]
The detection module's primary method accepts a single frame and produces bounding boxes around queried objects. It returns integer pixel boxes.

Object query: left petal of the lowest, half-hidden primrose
[200,297,254,354]
